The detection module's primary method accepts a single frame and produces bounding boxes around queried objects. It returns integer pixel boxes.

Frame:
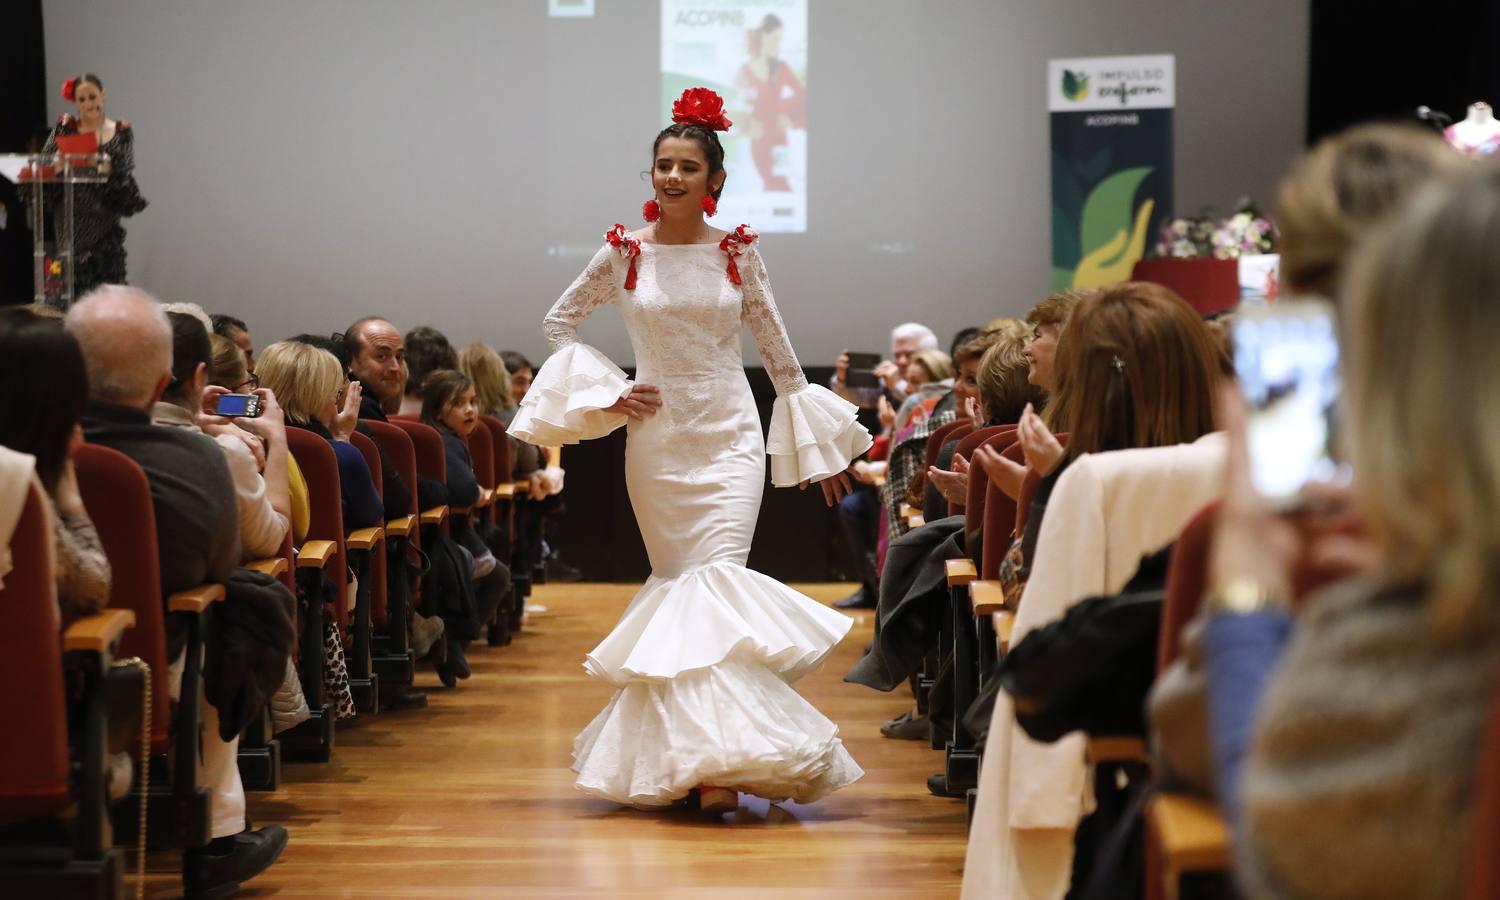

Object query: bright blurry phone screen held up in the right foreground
[1233,300,1340,504]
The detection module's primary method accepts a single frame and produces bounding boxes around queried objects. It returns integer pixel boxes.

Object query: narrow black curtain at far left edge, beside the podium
[0,0,47,303]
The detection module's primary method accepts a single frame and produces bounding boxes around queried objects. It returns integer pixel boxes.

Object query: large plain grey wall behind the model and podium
[45,0,1308,365]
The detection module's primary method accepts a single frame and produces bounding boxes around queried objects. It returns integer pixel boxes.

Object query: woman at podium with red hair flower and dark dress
[42,72,146,297]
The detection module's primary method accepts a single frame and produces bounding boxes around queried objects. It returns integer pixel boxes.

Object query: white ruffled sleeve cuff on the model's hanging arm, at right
[765,384,872,488]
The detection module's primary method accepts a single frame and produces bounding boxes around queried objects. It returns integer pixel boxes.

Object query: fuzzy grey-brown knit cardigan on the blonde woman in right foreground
[1236,579,1500,900]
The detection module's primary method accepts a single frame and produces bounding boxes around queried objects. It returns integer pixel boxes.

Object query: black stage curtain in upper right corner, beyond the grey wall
[1308,0,1500,144]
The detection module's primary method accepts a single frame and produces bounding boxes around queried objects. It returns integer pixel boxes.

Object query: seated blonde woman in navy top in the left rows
[257,341,386,531]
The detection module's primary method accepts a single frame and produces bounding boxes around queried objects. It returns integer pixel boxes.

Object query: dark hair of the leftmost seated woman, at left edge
[0,308,89,494]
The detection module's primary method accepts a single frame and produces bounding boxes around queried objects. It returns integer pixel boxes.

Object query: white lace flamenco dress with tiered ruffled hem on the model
[510,227,870,807]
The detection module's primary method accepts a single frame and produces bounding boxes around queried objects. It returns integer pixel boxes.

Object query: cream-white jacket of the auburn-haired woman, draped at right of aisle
[963,434,1226,900]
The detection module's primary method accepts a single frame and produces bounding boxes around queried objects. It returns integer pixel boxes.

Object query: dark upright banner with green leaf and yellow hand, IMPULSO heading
[1047,56,1176,290]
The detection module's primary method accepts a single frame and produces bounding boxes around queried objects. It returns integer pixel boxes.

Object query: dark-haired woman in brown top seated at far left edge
[0,308,110,629]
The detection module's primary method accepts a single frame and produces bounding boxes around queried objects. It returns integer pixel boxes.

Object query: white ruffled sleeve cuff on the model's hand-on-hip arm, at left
[509,344,632,447]
